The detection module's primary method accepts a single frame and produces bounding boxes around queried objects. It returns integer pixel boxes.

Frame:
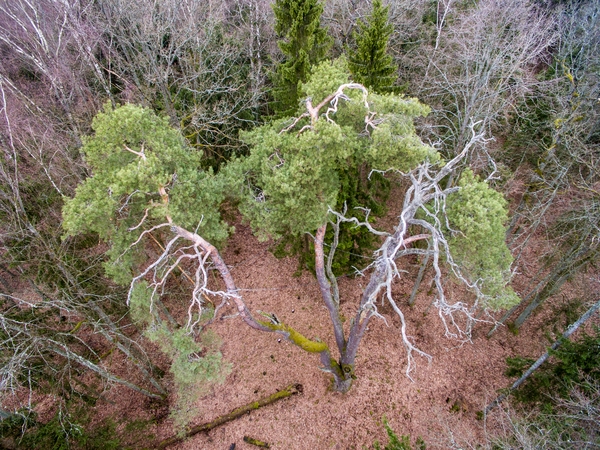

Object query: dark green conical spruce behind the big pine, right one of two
[348,0,398,92]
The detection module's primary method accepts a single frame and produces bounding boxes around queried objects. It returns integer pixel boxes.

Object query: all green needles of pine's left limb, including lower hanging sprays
[63,105,229,427]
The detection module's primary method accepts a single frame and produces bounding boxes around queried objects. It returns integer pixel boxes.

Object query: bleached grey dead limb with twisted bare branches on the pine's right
[350,123,484,378]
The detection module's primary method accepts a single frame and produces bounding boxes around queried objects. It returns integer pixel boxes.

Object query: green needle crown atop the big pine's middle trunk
[229,59,439,243]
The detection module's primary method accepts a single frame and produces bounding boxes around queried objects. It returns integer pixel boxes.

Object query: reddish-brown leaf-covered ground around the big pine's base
[4,185,590,450]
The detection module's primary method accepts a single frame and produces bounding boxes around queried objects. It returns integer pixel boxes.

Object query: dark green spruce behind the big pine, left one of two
[273,0,331,117]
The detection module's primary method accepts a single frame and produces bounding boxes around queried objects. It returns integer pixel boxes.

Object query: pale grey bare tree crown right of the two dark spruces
[417,0,554,163]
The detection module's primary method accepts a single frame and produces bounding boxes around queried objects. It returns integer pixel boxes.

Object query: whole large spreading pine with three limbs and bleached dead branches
[63,59,515,398]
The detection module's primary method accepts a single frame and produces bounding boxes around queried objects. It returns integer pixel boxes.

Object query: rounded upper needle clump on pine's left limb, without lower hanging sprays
[63,105,229,285]
